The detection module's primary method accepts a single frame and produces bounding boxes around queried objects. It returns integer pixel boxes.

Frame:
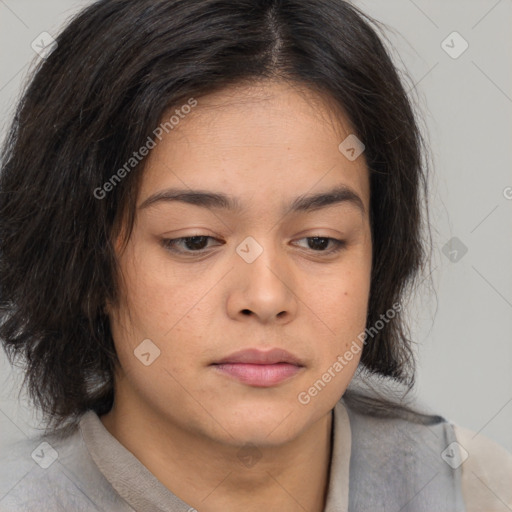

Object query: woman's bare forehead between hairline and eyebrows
[139,82,369,214]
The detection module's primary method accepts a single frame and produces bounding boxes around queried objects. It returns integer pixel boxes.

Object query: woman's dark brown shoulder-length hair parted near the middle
[0,0,427,427]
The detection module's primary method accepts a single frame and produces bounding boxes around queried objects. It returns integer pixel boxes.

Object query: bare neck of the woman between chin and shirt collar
[101,396,332,512]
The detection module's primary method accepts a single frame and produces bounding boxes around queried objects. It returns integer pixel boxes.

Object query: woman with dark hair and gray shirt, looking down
[0,0,512,512]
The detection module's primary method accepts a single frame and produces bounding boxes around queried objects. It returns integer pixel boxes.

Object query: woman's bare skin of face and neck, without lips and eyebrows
[101,82,372,512]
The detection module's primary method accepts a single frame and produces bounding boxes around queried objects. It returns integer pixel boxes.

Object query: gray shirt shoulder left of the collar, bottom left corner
[0,414,132,512]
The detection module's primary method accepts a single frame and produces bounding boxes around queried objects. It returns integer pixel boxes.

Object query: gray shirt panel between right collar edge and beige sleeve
[340,397,465,512]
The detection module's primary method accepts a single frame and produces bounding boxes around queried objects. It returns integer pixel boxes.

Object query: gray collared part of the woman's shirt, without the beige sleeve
[0,399,512,512]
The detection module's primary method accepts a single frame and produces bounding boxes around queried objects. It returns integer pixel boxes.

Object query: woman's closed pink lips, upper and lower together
[212,349,305,387]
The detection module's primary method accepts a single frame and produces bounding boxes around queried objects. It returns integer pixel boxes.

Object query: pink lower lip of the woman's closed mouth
[215,363,302,388]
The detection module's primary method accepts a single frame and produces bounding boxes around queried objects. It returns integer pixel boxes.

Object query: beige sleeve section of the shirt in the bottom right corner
[454,424,512,512]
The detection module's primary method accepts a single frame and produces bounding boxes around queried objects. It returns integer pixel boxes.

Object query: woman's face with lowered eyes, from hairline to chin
[110,83,372,445]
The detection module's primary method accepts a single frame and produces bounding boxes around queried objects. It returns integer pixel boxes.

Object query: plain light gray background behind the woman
[0,0,512,452]
